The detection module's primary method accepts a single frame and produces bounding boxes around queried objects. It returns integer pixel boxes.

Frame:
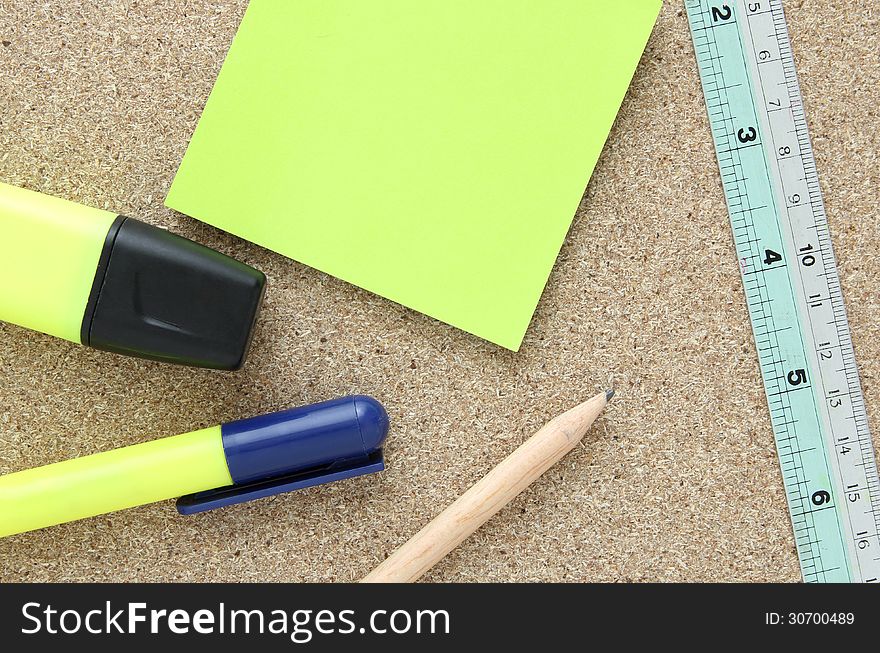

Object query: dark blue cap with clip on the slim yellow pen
[177,395,388,515]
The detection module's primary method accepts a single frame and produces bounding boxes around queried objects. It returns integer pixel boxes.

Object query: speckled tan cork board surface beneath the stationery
[0,0,880,581]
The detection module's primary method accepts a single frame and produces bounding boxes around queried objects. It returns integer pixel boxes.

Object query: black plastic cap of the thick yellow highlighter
[81,216,266,370]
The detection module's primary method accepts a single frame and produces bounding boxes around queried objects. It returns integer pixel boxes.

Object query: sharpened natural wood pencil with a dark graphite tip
[361,390,614,583]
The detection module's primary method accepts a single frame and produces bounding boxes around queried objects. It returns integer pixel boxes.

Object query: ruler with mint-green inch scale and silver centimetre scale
[686,0,880,582]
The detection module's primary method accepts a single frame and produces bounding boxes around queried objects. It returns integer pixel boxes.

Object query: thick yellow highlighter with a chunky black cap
[0,183,266,370]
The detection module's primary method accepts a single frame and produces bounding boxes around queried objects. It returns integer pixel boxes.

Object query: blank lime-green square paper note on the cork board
[166,0,661,350]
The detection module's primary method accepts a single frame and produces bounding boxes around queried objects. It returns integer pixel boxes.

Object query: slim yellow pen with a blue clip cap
[0,395,388,537]
